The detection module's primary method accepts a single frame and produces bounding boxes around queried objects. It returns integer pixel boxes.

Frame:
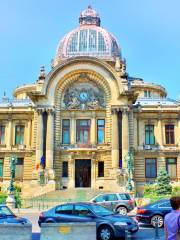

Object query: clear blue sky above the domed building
[0,0,180,99]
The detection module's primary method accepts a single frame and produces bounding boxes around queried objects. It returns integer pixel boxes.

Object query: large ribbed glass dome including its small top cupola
[54,6,120,65]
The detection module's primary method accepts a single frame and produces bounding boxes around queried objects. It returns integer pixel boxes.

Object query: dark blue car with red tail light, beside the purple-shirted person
[136,199,172,228]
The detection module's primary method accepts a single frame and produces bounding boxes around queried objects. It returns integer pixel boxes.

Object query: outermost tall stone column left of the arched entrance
[36,109,43,169]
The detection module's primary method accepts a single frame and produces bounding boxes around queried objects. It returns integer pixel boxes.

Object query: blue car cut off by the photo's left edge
[0,204,30,224]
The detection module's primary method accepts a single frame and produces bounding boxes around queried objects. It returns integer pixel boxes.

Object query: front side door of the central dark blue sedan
[73,204,95,222]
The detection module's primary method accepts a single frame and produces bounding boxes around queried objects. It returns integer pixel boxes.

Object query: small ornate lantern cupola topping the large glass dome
[79,5,101,26]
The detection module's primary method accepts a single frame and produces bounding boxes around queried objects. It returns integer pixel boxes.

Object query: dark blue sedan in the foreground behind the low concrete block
[38,202,139,240]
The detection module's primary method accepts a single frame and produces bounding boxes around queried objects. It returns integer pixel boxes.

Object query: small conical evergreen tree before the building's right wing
[156,170,172,195]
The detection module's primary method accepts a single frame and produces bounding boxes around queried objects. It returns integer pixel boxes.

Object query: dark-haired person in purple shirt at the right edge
[164,196,180,240]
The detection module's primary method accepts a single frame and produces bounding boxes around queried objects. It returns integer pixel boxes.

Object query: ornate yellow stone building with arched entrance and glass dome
[0,6,180,194]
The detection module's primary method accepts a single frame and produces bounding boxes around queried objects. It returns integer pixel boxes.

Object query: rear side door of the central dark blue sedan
[55,204,76,222]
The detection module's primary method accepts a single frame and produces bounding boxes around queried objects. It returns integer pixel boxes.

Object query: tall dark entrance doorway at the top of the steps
[75,160,91,187]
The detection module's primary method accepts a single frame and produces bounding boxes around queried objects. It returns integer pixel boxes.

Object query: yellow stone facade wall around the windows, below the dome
[0,58,180,195]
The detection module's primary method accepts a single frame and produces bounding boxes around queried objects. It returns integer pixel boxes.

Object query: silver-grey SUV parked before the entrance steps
[90,193,135,215]
